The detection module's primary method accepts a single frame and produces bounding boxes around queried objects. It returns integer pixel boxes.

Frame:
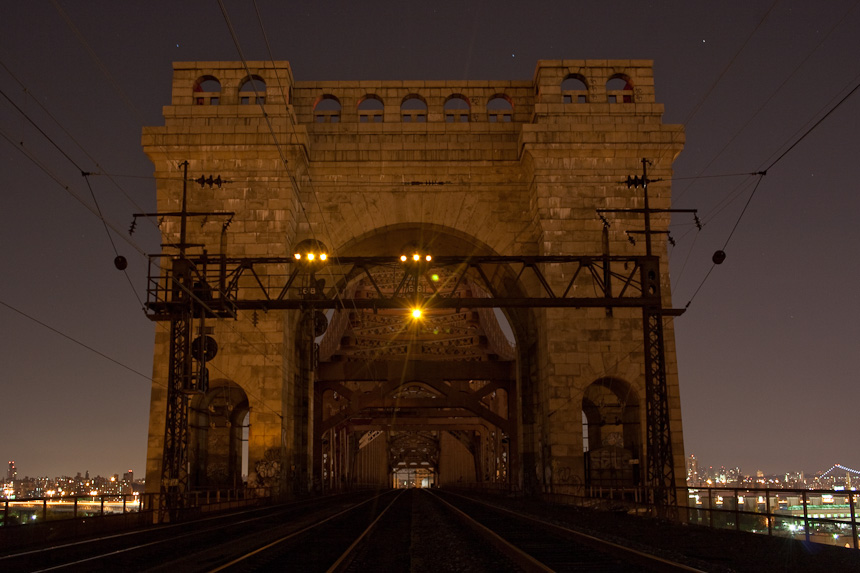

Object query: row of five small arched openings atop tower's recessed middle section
[314,94,514,123]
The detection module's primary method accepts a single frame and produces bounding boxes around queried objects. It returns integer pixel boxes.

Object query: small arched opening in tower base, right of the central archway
[582,378,642,488]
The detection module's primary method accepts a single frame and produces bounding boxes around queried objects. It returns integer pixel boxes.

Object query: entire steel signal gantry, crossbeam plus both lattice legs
[146,253,683,514]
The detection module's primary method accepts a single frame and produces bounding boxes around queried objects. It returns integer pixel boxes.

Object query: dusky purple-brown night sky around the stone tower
[0,0,860,476]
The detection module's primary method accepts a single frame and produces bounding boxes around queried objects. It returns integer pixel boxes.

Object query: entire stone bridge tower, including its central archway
[143,60,684,494]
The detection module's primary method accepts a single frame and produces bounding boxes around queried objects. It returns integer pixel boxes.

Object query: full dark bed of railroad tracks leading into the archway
[0,490,698,573]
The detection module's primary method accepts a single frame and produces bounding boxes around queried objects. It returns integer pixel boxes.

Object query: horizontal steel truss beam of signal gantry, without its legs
[147,255,660,312]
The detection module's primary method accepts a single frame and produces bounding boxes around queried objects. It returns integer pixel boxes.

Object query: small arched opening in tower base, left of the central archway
[189,380,250,489]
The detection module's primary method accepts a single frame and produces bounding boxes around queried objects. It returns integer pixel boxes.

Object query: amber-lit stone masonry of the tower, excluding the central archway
[143,60,684,491]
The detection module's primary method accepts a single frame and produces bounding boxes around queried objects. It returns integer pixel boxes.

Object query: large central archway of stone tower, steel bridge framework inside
[299,226,532,490]
